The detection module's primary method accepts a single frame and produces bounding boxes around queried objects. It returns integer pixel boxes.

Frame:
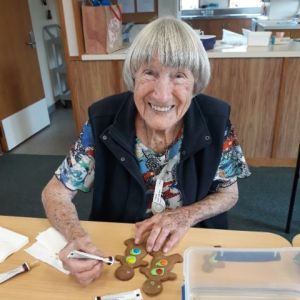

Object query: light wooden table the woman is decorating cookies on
[0,216,291,300]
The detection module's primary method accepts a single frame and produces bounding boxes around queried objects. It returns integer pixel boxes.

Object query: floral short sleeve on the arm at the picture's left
[55,122,95,192]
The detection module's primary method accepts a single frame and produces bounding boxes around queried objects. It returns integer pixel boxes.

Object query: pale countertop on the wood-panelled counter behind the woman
[81,41,300,61]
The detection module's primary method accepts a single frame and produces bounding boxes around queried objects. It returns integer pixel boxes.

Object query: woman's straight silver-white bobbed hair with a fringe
[123,17,210,94]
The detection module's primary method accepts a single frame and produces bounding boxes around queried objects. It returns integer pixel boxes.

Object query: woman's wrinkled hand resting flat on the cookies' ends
[135,207,191,253]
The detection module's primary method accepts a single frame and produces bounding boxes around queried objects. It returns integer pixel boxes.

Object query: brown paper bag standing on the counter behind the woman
[82,5,123,54]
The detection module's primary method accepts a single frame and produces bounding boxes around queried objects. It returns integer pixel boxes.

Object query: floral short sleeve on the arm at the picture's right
[211,122,251,192]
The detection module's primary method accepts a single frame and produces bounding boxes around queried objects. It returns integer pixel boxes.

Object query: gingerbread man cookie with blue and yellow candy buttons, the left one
[115,239,148,281]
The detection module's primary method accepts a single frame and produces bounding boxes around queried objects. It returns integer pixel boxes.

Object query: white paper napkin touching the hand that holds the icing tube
[25,227,69,274]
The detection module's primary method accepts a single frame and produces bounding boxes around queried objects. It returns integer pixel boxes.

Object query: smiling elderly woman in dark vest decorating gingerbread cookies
[42,18,249,285]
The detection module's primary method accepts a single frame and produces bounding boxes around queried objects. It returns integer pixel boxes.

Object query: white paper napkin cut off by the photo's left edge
[0,226,29,263]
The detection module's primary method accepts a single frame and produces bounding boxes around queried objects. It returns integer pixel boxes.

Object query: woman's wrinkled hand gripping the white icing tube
[59,236,103,286]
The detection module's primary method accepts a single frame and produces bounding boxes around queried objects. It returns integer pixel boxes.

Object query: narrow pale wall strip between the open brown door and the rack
[28,0,59,108]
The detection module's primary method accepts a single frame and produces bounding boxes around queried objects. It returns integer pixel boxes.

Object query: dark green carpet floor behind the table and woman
[0,154,300,240]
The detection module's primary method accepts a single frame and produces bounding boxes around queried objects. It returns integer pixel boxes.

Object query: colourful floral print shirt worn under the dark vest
[55,122,250,209]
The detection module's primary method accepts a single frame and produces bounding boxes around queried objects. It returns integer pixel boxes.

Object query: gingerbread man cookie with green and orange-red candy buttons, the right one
[140,251,183,296]
